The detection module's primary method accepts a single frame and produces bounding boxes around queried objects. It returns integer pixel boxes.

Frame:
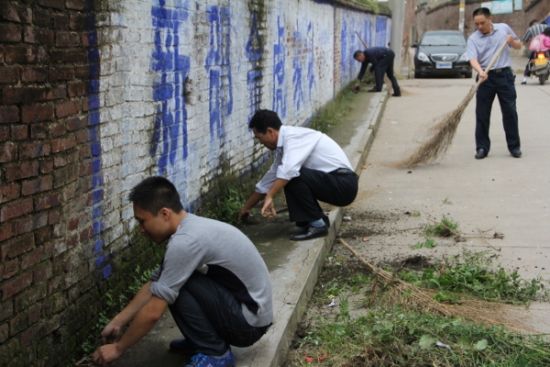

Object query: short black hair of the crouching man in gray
[128,176,183,215]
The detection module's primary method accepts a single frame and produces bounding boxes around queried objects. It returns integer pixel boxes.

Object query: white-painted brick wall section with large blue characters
[98,0,391,268]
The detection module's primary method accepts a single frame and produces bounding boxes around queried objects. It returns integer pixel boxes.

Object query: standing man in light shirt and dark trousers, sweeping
[467,7,521,159]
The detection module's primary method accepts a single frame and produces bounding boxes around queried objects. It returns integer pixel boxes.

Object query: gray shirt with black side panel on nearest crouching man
[151,214,273,327]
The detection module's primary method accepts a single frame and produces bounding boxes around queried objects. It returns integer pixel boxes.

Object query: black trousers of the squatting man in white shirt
[285,168,359,224]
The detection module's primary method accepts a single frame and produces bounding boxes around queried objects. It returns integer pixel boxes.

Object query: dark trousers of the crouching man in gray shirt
[170,272,269,355]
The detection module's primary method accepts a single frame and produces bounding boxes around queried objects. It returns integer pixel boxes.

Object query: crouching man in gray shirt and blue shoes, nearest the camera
[93,177,273,367]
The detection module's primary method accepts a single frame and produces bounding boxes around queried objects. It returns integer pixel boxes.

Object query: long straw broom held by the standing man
[395,42,507,168]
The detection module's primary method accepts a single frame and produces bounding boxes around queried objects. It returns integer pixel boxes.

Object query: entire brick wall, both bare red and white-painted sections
[0,0,391,365]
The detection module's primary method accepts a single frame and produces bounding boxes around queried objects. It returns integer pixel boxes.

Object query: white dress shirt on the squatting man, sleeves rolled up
[256,125,352,194]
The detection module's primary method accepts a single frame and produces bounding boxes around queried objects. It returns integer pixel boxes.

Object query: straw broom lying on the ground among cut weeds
[338,238,534,333]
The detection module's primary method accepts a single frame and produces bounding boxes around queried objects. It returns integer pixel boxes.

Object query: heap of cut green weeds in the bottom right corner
[296,306,550,367]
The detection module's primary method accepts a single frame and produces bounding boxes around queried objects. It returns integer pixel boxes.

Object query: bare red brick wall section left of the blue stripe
[0,0,104,365]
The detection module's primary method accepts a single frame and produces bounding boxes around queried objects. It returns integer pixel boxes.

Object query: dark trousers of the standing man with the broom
[475,68,520,152]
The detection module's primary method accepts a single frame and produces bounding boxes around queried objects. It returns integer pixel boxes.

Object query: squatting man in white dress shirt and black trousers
[240,110,358,241]
